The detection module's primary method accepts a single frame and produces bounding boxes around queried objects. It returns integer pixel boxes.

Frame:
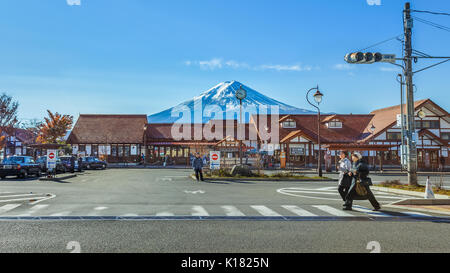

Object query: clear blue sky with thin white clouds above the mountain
[0,0,450,119]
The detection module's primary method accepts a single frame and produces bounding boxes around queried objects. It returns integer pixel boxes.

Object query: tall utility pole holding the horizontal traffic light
[403,2,418,186]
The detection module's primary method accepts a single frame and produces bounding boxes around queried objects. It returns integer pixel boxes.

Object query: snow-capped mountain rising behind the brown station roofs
[148,81,315,123]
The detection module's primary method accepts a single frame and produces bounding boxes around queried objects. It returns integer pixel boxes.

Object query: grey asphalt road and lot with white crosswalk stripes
[0,169,450,253]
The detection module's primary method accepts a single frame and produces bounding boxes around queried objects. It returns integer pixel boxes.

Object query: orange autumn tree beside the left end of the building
[37,110,73,144]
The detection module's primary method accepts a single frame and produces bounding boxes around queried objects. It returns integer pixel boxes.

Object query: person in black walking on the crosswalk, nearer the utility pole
[344,152,381,211]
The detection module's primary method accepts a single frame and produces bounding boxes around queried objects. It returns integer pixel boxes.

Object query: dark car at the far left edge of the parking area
[0,156,41,179]
